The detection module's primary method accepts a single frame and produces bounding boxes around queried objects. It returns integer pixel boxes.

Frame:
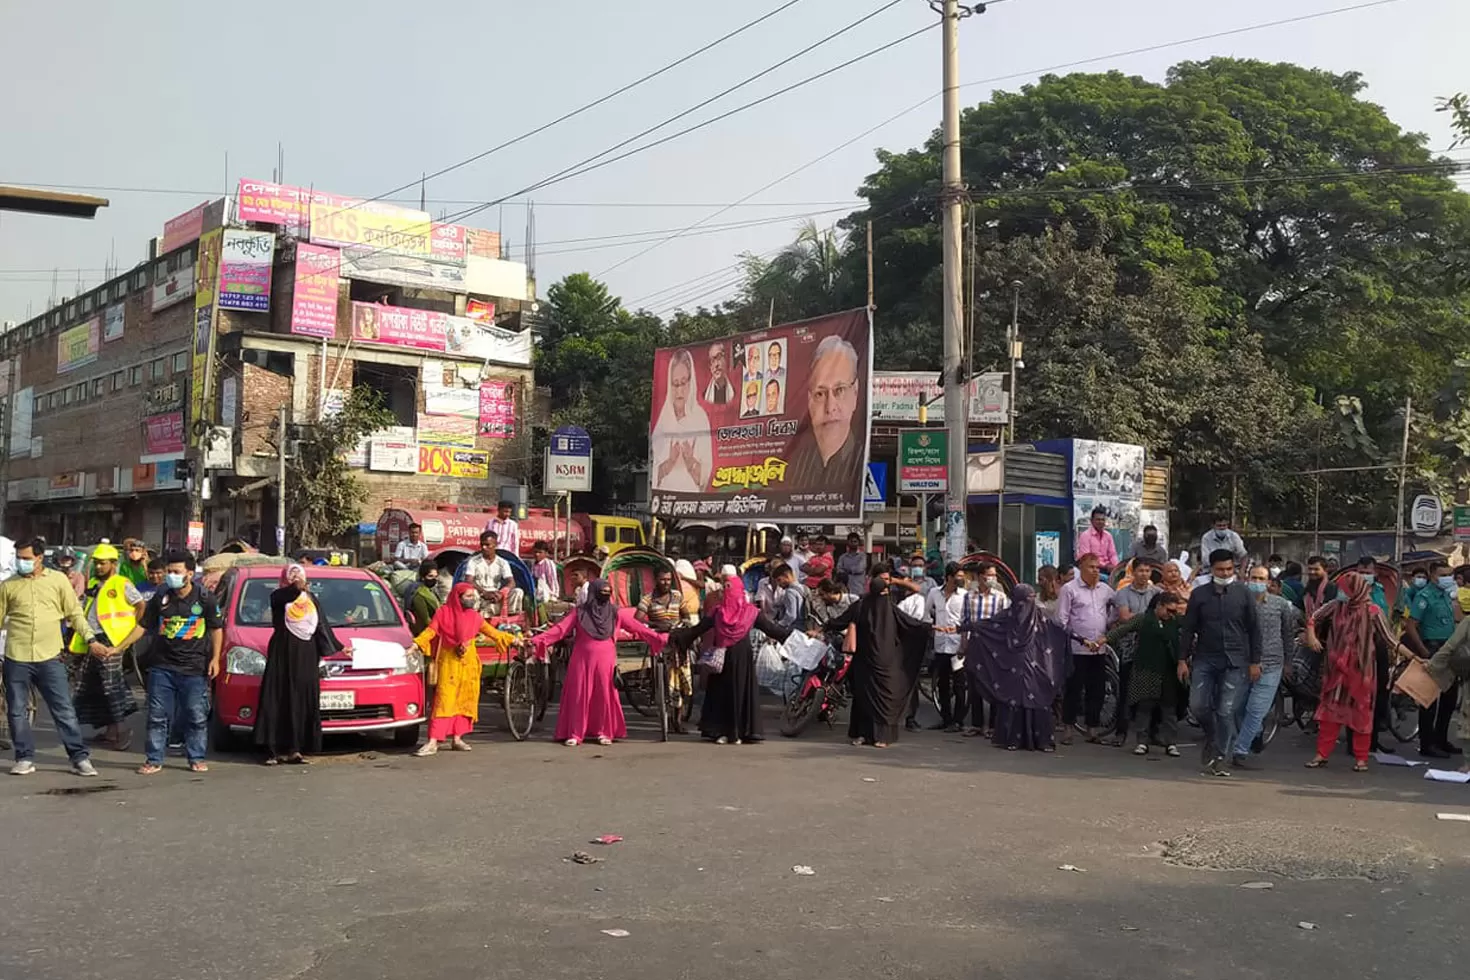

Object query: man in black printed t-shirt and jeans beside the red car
[116,551,225,776]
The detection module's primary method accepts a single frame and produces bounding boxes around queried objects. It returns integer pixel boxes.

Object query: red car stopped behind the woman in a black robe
[210,564,426,749]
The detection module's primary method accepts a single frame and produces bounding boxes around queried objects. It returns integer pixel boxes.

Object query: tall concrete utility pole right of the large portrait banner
[929,0,970,561]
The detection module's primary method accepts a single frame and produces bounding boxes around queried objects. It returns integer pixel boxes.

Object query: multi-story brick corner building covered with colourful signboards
[0,181,534,550]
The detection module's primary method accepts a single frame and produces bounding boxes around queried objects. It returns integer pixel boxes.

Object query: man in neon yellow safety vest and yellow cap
[69,541,143,752]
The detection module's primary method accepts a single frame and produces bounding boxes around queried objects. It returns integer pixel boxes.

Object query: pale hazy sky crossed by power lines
[0,0,1470,320]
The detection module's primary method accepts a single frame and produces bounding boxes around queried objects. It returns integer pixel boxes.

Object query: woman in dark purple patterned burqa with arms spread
[964,585,1067,752]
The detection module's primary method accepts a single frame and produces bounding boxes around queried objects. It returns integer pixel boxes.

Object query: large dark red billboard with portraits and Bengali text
[648,310,873,523]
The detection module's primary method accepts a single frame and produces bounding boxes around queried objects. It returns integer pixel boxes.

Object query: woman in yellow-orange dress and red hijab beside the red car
[413,582,516,758]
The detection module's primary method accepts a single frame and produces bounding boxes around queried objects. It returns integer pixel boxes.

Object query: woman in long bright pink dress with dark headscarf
[532,579,669,745]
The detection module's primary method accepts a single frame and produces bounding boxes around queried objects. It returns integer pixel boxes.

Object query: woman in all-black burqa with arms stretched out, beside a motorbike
[825,564,933,748]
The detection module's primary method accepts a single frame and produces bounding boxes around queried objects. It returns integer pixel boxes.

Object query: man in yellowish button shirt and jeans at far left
[0,541,107,776]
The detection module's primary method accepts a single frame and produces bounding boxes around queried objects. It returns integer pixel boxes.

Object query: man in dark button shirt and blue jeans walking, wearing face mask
[1179,548,1261,777]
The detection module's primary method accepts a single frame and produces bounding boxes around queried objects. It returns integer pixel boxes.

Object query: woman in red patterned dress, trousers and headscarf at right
[1302,572,1413,773]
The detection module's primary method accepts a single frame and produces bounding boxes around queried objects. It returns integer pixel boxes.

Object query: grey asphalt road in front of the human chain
[0,711,1470,980]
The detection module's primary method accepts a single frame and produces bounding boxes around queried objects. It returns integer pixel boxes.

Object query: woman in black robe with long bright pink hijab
[673,566,791,745]
